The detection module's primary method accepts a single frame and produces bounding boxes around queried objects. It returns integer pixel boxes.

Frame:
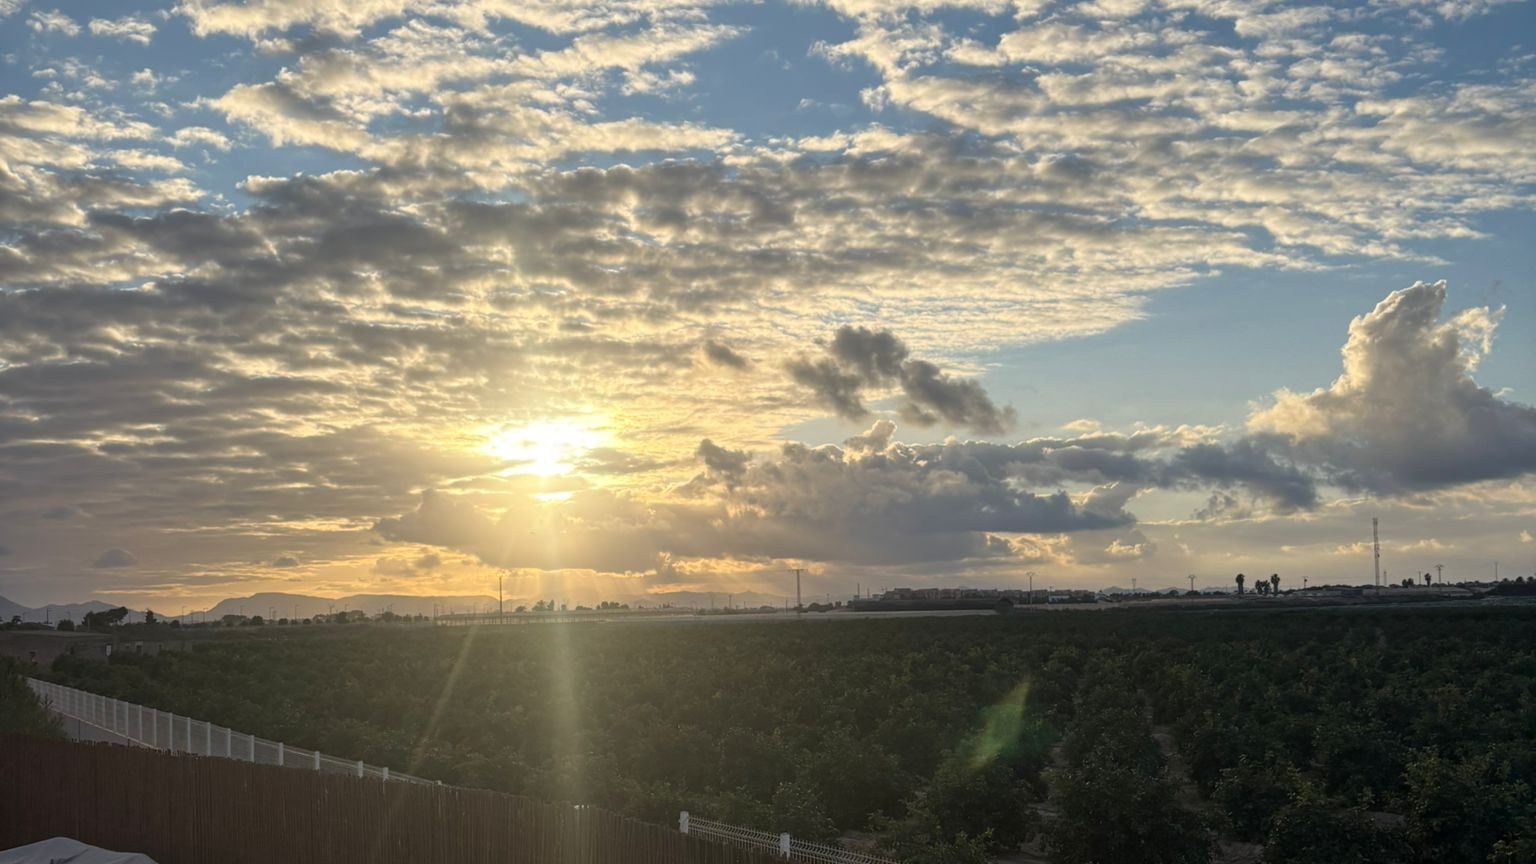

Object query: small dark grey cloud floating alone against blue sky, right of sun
[786,324,1015,435]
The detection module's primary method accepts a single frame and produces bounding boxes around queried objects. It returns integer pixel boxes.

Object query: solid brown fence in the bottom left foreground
[0,733,782,864]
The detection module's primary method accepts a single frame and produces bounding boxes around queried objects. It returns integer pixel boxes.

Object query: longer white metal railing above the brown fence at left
[26,678,432,783]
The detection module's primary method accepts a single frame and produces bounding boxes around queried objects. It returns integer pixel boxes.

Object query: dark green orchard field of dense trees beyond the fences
[52,607,1536,864]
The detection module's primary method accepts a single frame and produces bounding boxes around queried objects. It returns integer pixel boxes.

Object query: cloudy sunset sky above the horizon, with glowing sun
[0,0,1536,609]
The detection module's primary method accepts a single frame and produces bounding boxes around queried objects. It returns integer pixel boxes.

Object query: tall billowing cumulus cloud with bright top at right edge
[1249,281,1536,493]
